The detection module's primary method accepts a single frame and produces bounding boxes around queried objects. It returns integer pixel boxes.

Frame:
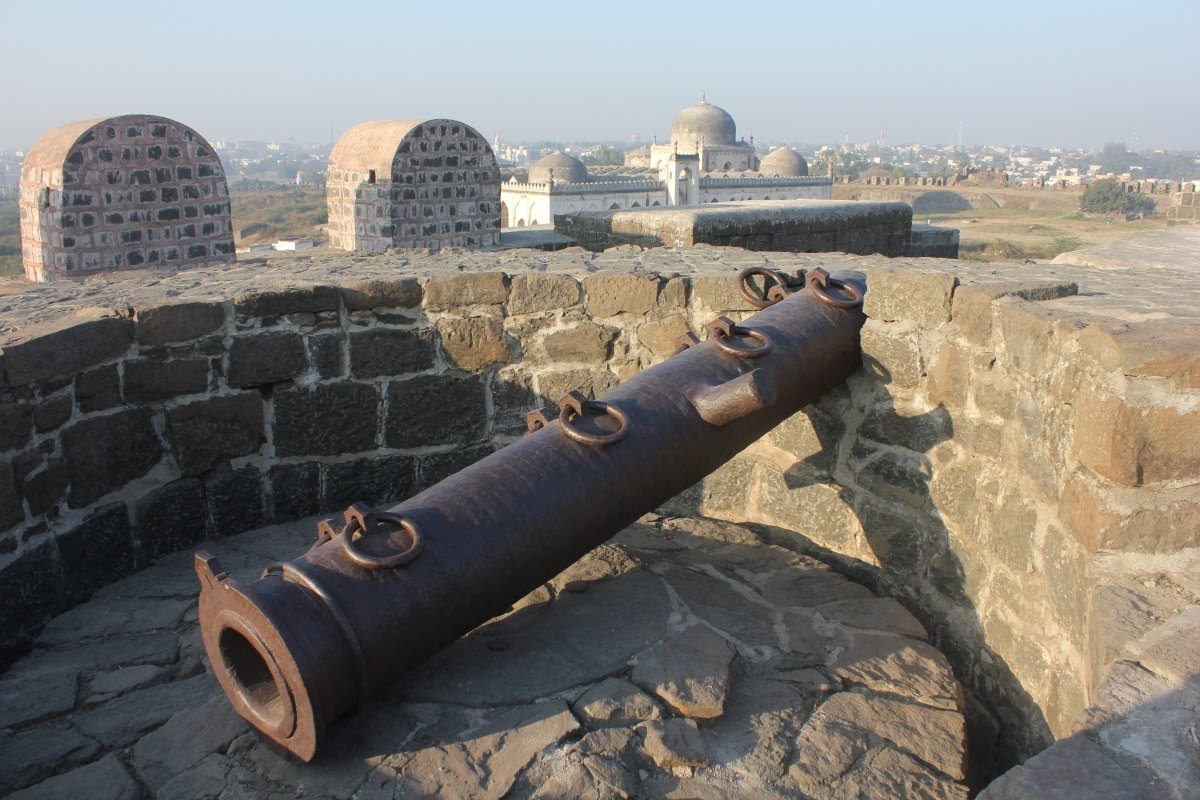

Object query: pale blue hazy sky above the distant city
[0,0,1200,150]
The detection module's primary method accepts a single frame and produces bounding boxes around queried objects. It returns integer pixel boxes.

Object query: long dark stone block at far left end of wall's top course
[4,317,131,386]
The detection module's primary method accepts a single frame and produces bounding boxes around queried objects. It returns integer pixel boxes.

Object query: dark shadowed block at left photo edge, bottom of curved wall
[0,541,66,670]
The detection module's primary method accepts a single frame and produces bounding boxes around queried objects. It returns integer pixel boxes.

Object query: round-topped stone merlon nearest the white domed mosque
[325,120,500,252]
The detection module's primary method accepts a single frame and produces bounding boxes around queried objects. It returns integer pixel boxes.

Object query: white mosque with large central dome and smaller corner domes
[500,100,833,228]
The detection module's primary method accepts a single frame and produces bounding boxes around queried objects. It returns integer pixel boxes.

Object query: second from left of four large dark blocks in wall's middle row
[167,392,266,475]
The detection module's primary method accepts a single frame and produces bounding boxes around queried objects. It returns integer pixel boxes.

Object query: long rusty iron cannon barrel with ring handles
[196,267,866,760]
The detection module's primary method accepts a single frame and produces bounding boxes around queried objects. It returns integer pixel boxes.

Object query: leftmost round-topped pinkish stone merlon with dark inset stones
[19,114,234,281]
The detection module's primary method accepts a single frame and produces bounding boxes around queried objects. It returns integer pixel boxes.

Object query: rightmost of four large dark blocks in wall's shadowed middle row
[384,374,487,447]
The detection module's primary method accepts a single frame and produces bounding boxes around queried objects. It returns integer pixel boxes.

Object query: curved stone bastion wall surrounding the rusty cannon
[0,247,1200,786]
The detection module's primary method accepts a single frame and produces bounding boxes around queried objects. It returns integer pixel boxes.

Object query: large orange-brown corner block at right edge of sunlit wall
[1074,389,1200,486]
